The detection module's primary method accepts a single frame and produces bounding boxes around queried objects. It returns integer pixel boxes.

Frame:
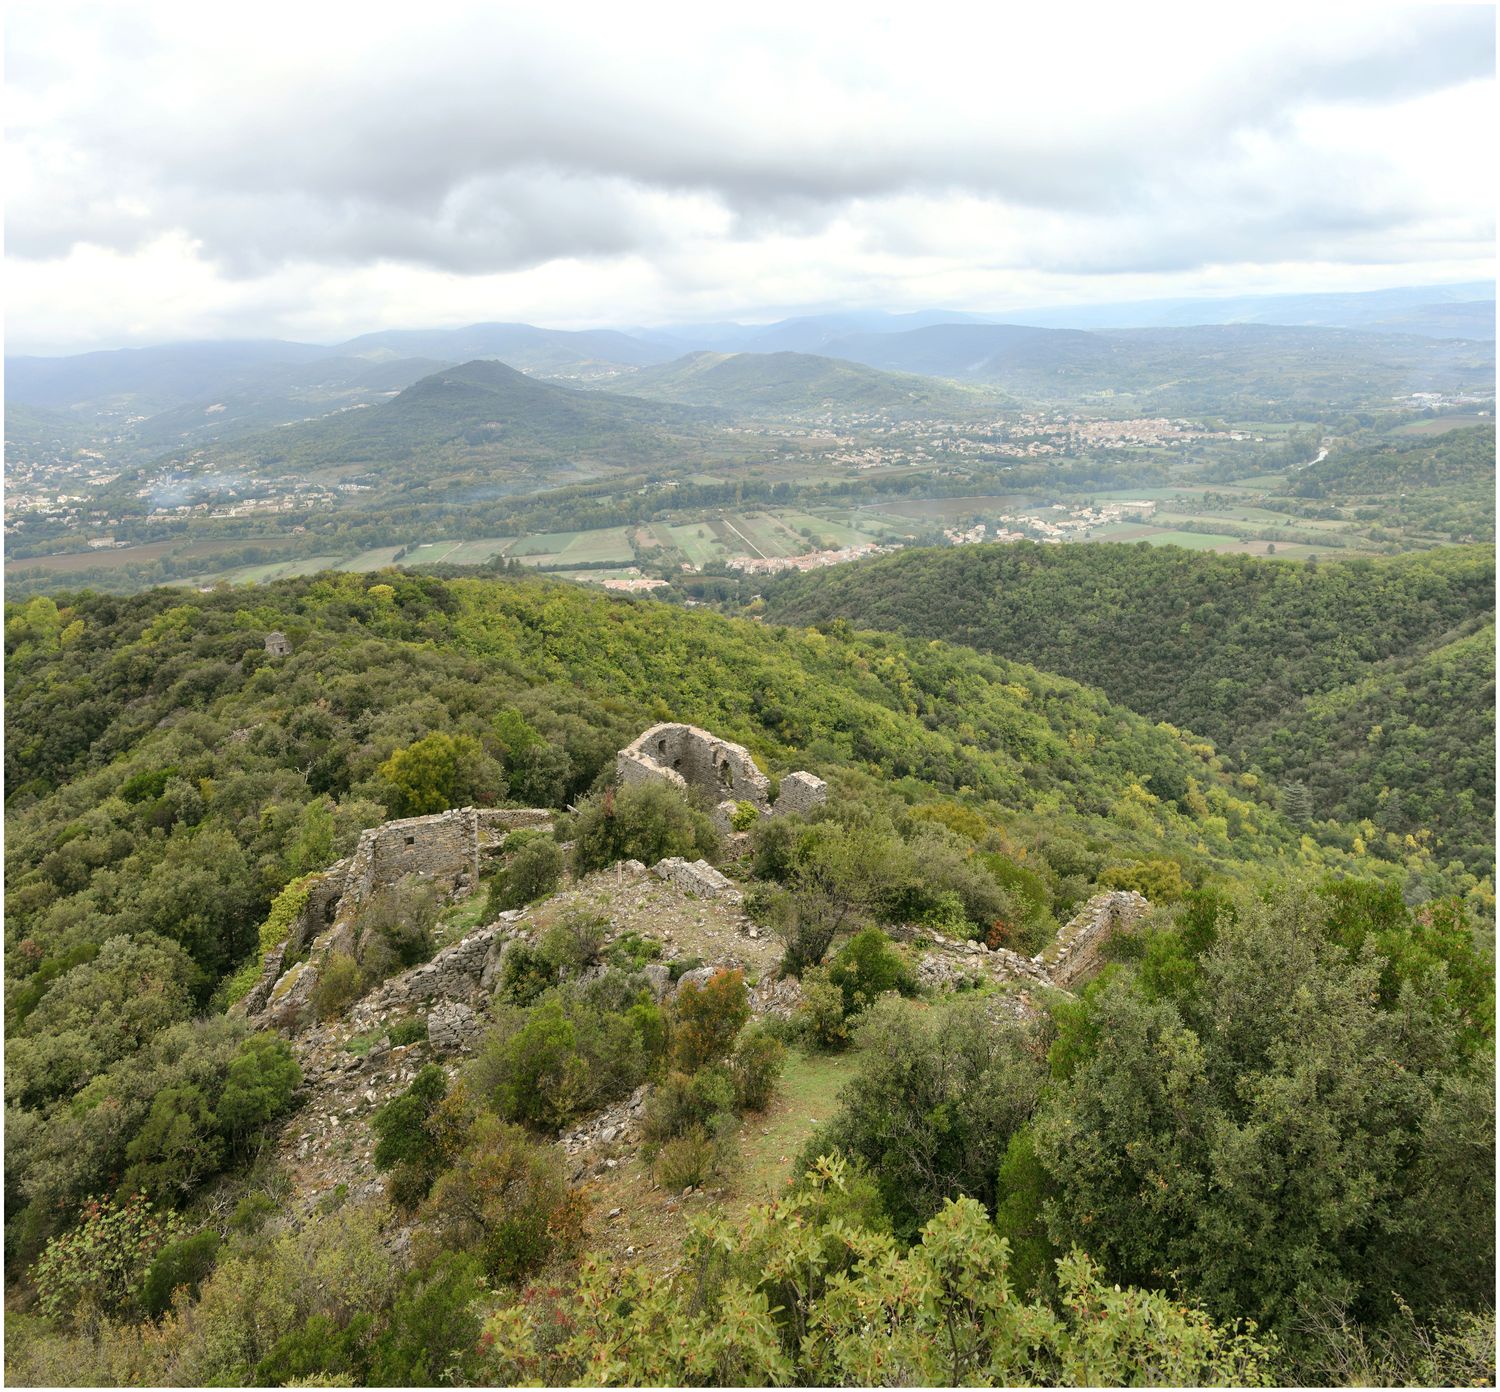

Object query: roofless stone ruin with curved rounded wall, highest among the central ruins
[615,723,828,831]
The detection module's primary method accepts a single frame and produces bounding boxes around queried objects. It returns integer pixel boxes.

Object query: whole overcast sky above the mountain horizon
[6,0,1497,353]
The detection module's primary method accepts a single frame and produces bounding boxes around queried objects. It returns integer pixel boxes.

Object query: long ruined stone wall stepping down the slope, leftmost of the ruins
[236,807,552,1028]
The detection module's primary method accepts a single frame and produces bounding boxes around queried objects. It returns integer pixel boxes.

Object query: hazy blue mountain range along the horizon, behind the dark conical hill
[6,284,1494,458]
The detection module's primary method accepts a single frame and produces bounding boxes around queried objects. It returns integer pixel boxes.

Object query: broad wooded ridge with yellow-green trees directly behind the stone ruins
[6,572,1464,1020]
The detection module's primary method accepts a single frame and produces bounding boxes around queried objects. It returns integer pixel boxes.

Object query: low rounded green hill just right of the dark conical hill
[609,353,999,419]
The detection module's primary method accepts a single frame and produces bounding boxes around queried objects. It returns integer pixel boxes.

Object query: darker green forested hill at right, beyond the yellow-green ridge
[767,543,1494,873]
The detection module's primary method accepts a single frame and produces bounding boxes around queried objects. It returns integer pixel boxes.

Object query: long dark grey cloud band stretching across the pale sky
[8,8,1494,276]
